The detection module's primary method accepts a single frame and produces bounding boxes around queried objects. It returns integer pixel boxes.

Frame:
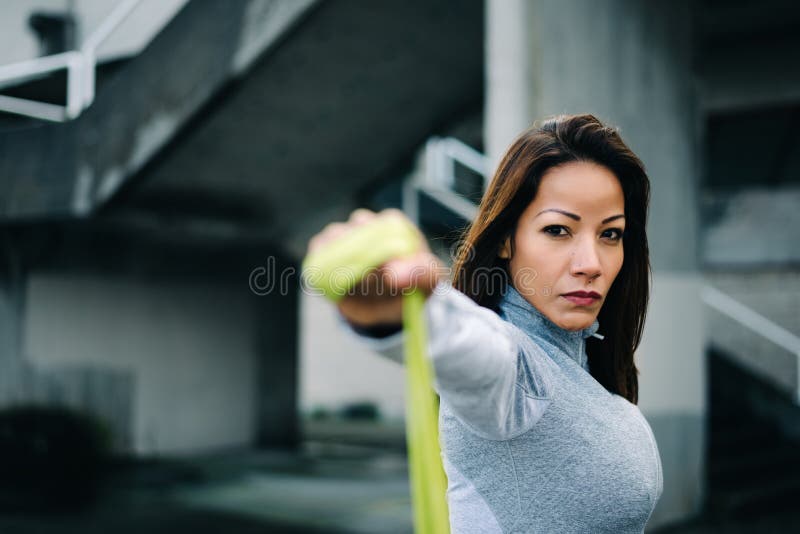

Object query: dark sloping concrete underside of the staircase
[104,0,484,257]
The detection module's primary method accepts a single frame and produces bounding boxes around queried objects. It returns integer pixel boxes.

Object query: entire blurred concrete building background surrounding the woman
[0,0,800,533]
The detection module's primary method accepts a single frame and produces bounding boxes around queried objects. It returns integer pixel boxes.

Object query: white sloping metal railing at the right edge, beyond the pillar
[700,285,800,404]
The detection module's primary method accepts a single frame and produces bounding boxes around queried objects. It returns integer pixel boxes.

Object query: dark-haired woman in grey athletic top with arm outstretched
[310,115,663,533]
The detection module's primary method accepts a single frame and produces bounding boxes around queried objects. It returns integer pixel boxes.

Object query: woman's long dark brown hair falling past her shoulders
[453,115,650,404]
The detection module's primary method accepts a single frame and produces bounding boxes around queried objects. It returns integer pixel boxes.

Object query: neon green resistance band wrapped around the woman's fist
[302,217,450,534]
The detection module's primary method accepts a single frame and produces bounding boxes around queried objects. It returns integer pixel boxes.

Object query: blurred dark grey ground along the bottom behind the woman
[0,436,800,534]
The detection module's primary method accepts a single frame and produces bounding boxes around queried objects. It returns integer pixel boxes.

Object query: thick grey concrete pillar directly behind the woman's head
[485,0,706,527]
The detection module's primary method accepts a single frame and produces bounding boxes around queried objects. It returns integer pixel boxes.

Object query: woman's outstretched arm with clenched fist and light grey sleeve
[309,210,549,439]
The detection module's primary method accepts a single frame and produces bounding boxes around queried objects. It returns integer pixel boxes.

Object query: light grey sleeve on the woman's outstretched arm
[341,282,550,440]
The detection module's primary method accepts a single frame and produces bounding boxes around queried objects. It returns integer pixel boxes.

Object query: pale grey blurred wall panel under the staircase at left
[23,274,257,454]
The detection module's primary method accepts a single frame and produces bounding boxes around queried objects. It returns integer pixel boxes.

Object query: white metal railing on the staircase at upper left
[0,0,141,122]
